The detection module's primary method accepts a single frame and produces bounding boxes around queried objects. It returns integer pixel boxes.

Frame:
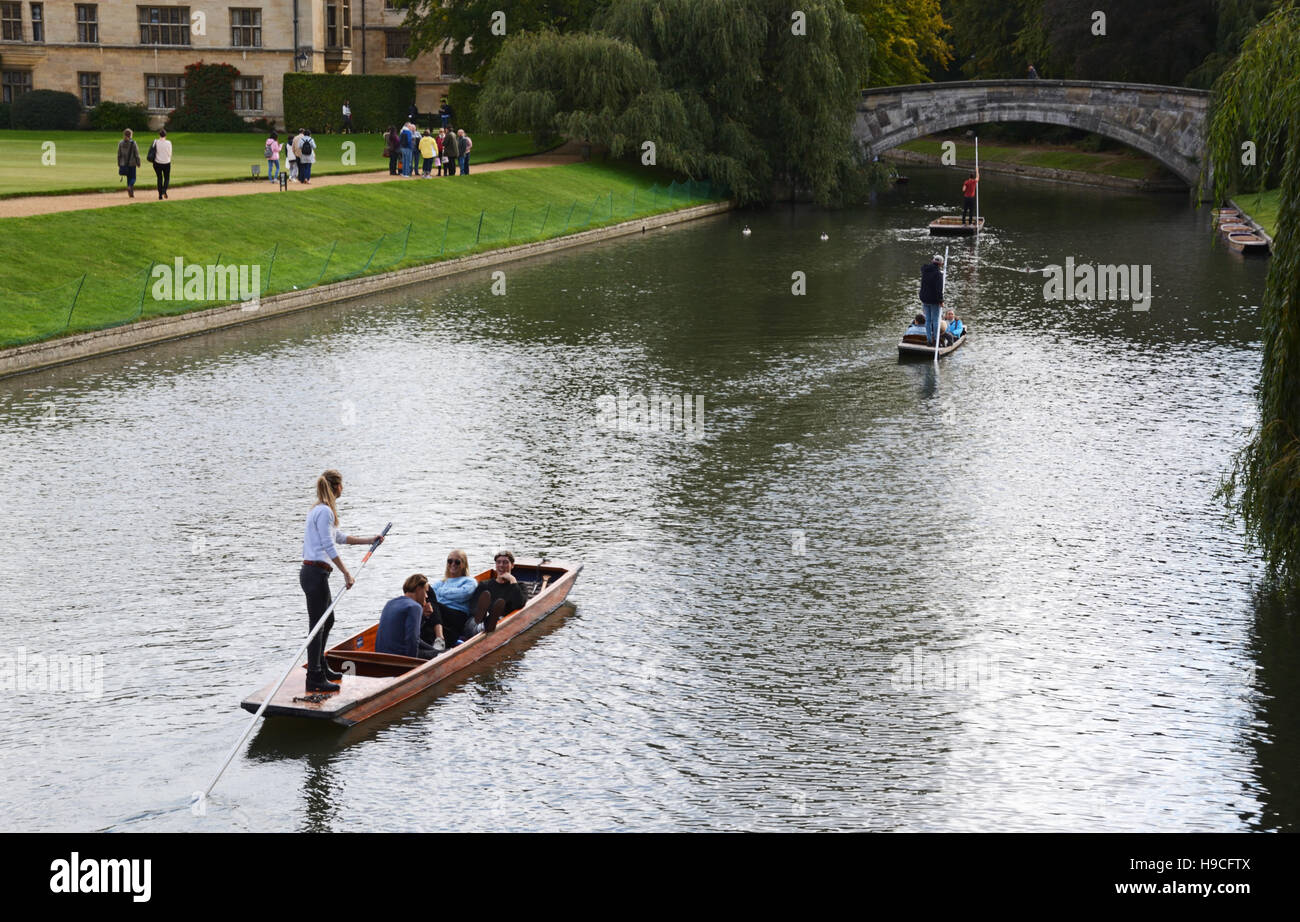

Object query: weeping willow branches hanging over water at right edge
[1201,0,1300,589]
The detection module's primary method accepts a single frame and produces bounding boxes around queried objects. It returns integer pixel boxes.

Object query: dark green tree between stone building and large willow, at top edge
[394,0,610,81]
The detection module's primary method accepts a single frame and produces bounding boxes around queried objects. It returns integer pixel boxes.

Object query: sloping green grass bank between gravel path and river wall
[0,163,725,346]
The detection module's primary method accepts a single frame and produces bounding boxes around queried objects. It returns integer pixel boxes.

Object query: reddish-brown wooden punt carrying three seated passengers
[241,559,582,727]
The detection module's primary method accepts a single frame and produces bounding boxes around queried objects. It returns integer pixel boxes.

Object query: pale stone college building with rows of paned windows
[0,0,455,125]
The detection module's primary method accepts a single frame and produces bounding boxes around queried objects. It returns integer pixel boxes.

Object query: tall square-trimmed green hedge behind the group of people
[285,74,415,134]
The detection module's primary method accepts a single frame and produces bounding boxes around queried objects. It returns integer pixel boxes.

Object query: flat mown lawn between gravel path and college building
[0,131,553,198]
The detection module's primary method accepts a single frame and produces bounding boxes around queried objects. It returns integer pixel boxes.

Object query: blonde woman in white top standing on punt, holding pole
[298,469,384,692]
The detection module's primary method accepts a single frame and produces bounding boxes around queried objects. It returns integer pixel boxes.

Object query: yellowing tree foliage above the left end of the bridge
[844,0,953,86]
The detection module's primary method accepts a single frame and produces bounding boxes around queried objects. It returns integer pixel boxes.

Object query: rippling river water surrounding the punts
[0,168,1300,831]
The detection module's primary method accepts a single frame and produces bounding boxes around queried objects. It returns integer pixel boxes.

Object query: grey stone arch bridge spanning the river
[854,79,1210,186]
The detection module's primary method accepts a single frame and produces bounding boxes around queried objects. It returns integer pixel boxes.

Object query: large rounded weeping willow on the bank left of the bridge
[478,0,867,203]
